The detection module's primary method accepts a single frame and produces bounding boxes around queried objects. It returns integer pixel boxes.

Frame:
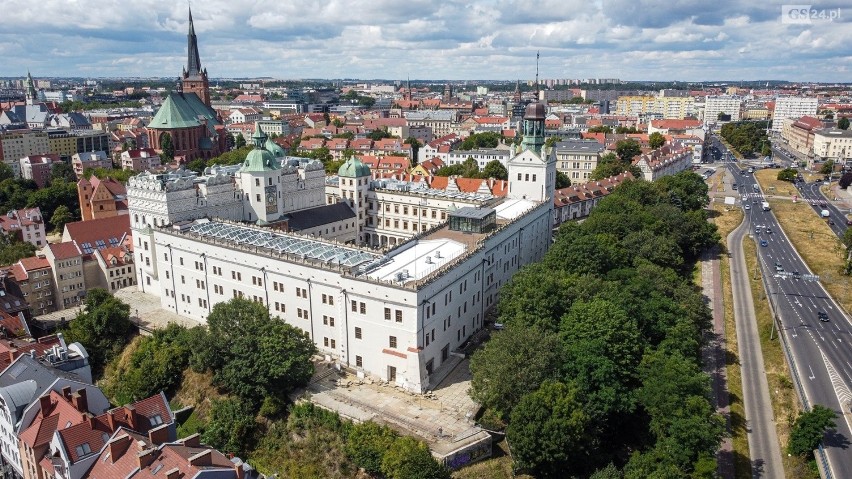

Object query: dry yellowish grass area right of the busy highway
[755,170,852,312]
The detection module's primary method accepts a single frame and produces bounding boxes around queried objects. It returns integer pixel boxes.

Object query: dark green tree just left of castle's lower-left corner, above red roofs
[61,288,135,377]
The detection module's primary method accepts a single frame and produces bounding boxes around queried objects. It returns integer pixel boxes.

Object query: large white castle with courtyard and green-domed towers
[127,112,556,392]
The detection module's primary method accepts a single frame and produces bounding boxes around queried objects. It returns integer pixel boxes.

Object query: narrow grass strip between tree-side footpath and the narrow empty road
[713,204,752,479]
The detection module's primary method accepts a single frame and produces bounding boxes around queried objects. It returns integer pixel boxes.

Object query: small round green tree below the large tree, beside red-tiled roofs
[201,398,257,457]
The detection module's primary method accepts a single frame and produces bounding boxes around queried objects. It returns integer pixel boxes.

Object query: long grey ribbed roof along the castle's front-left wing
[189,221,380,266]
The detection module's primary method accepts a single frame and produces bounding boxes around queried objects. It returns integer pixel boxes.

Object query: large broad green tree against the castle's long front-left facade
[191,298,316,403]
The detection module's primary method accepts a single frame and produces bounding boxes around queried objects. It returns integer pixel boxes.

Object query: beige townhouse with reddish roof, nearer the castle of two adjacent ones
[43,241,86,309]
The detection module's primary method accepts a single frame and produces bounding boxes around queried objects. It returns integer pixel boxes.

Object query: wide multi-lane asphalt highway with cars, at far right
[728,144,852,478]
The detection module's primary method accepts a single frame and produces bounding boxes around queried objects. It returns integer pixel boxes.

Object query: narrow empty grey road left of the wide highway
[728,218,784,478]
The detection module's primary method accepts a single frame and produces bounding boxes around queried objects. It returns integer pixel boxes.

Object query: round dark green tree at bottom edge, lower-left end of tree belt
[506,382,591,477]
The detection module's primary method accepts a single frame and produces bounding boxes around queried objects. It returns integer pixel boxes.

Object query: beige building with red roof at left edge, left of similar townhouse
[5,256,55,316]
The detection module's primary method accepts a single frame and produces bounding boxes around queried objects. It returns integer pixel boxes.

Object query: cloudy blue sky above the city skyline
[0,0,852,82]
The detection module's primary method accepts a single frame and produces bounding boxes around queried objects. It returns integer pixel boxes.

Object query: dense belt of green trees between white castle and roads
[470,172,724,478]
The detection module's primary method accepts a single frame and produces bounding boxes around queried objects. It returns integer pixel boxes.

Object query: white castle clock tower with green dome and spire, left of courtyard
[239,123,284,225]
